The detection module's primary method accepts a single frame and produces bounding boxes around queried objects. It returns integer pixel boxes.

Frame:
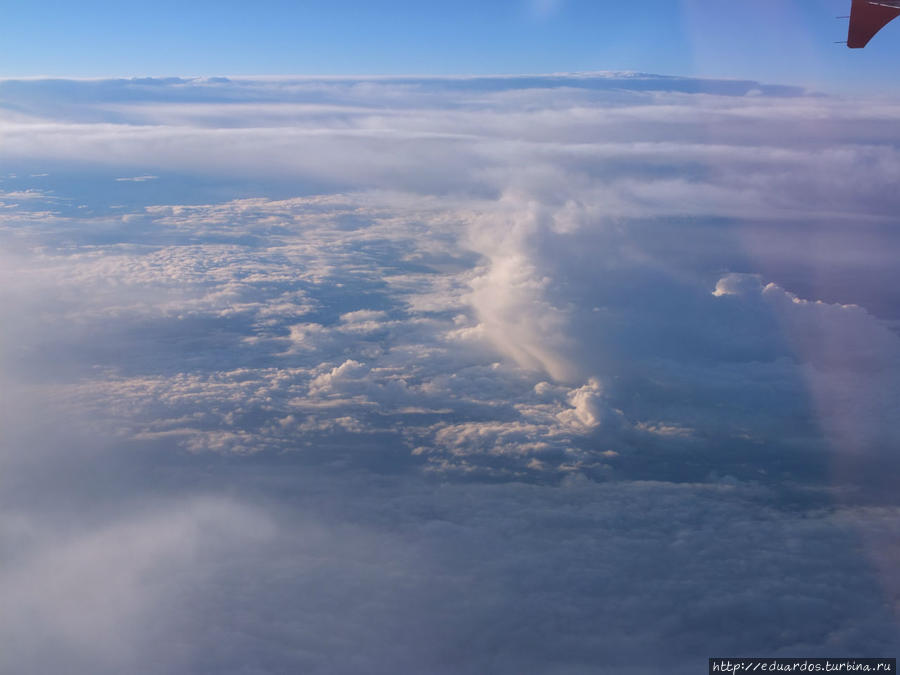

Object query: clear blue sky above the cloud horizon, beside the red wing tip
[0,0,900,91]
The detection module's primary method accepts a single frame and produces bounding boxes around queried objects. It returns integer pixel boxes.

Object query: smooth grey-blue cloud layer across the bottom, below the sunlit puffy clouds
[0,462,898,673]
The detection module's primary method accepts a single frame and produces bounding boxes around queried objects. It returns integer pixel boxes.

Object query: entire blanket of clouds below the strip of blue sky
[0,73,900,674]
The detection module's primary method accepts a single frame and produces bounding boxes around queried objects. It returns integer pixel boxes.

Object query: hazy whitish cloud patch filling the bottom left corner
[0,498,276,672]
